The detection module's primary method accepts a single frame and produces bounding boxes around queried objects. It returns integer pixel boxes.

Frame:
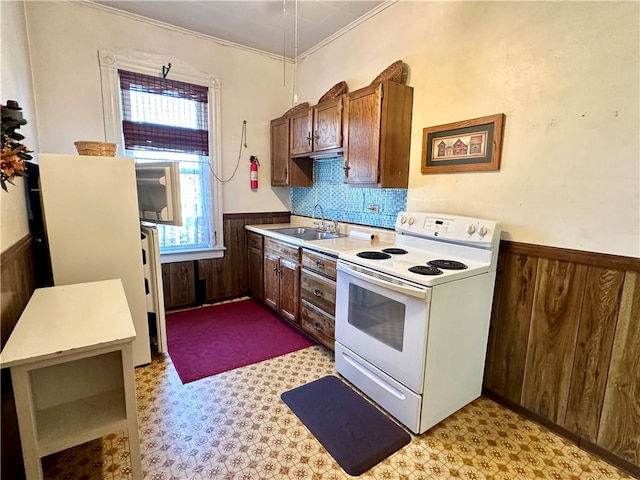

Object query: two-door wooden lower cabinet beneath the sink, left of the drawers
[264,238,300,324]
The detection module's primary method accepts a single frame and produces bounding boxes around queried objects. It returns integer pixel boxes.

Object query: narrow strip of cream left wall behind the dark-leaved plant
[0,1,38,252]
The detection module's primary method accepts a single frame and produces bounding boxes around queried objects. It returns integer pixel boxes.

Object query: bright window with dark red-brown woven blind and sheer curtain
[118,70,214,254]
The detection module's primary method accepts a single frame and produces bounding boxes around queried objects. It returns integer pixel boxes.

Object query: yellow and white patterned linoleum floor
[43,346,631,480]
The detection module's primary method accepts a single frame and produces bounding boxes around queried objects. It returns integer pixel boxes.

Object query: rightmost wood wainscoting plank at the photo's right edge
[597,271,640,466]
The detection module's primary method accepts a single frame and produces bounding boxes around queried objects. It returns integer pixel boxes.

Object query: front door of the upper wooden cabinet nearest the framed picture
[344,84,382,184]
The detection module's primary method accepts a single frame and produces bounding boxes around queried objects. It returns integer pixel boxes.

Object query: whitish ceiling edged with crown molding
[94,0,390,59]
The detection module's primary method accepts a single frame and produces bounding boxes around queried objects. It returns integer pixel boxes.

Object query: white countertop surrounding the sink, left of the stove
[245,217,395,257]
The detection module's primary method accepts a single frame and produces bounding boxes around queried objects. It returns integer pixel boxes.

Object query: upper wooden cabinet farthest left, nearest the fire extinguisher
[271,116,313,187]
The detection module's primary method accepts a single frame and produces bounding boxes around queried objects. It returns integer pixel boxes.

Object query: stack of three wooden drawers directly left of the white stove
[300,248,336,350]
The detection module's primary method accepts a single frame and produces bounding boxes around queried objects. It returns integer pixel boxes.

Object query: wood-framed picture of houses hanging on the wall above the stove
[421,113,504,175]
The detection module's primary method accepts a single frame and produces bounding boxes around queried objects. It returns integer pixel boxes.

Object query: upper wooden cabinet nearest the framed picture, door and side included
[344,81,413,188]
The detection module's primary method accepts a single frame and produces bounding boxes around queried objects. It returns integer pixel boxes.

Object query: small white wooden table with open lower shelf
[0,280,142,480]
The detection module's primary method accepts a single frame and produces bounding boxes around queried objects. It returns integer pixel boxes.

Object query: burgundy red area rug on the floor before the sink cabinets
[167,299,315,383]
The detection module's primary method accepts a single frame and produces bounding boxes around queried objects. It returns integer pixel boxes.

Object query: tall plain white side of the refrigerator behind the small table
[38,154,151,365]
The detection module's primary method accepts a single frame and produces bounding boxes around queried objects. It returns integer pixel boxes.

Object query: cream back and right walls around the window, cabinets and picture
[12,0,640,257]
